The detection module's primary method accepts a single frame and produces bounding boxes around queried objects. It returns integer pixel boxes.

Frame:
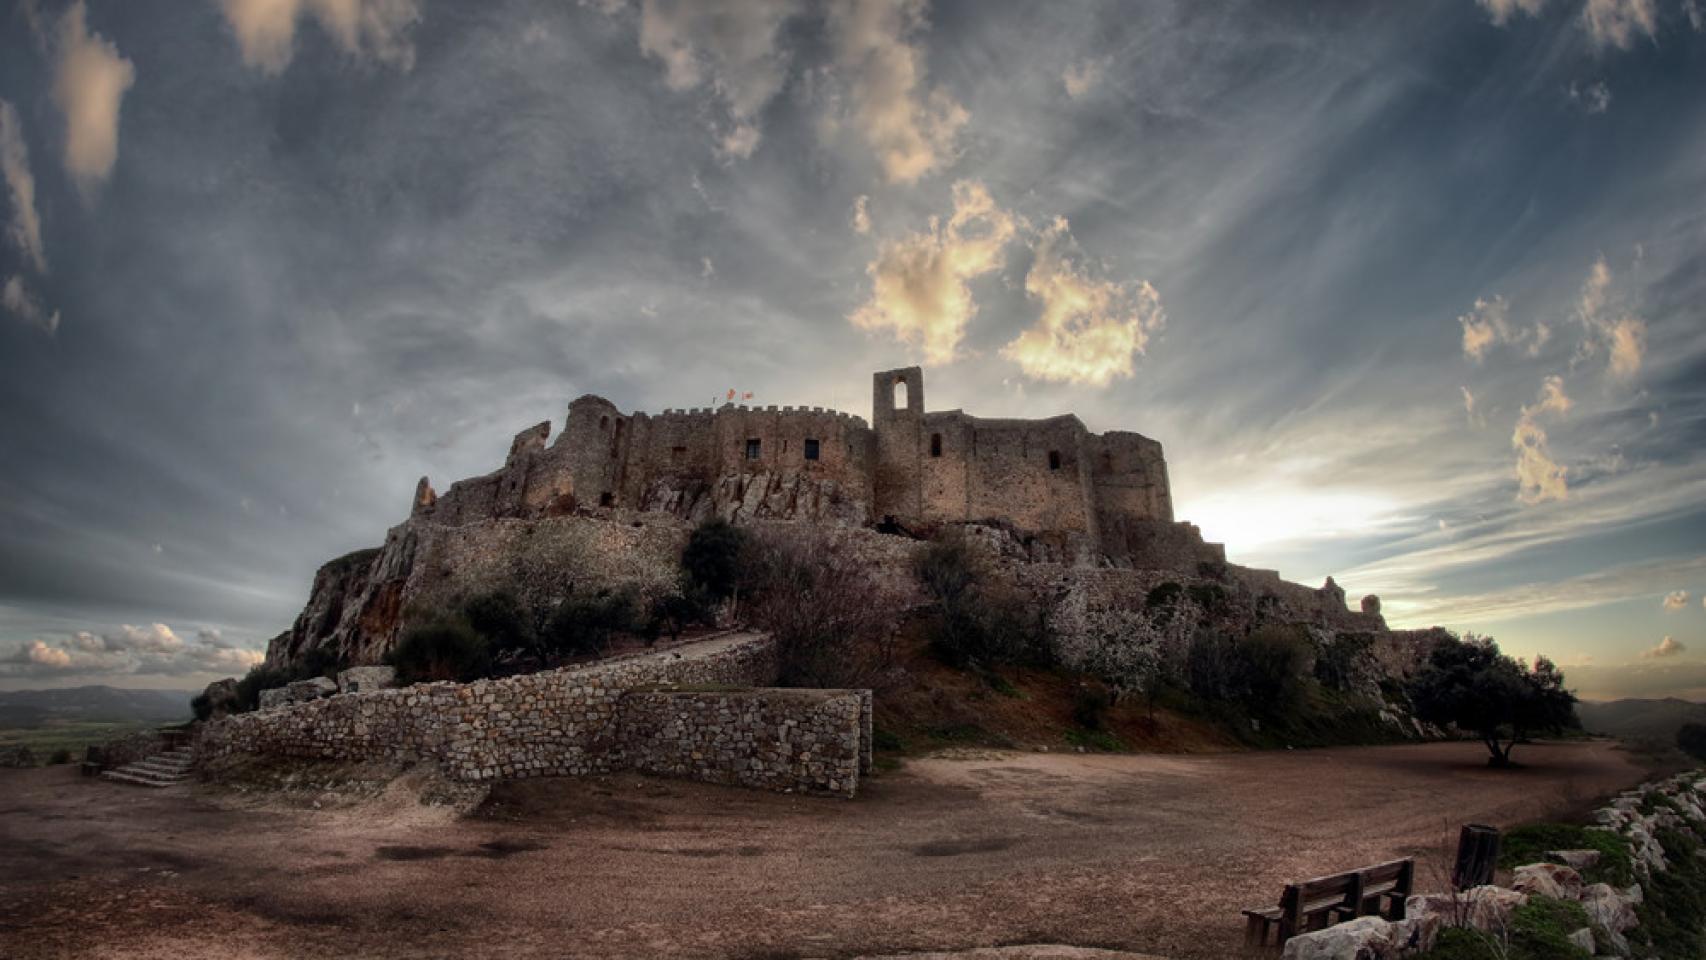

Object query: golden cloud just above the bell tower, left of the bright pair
[848,181,1013,363]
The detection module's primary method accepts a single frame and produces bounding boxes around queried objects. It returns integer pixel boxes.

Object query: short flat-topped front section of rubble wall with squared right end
[618,689,870,796]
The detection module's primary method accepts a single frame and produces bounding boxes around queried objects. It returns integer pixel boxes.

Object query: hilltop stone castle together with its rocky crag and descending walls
[268,368,1435,697]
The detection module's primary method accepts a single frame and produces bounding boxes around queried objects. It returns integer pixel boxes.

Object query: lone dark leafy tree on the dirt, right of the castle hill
[1409,636,1576,767]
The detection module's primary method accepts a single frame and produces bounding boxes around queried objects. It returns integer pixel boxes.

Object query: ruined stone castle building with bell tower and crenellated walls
[413,367,1194,563]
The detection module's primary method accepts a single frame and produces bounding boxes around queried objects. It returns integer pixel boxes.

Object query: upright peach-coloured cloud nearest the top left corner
[53,0,136,191]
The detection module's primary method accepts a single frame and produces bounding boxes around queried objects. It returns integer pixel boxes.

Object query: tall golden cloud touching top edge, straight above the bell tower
[829,0,971,184]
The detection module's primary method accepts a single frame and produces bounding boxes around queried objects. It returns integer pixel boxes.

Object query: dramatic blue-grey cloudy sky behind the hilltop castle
[0,0,1706,699]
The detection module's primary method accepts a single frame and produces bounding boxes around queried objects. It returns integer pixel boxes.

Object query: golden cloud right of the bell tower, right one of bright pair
[1001,217,1167,387]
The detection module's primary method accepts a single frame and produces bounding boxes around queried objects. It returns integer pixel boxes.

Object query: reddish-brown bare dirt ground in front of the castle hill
[0,742,1645,958]
